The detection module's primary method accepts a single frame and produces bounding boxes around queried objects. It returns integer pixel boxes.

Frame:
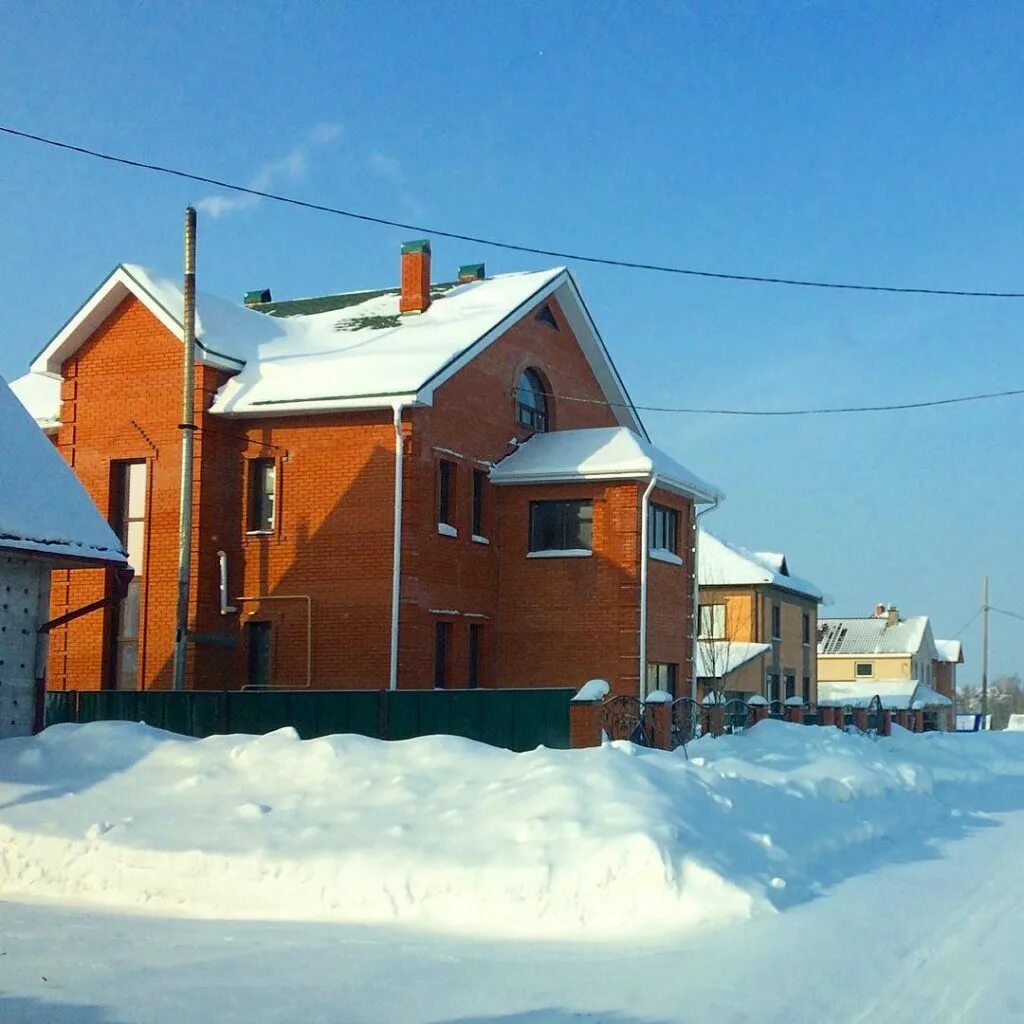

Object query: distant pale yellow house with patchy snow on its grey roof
[817,604,950,728]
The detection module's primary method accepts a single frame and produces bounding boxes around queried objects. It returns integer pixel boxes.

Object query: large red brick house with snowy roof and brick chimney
[16,242,719,693]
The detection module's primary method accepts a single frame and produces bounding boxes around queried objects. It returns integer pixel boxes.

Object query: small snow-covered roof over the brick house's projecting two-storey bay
[490,427,722,504]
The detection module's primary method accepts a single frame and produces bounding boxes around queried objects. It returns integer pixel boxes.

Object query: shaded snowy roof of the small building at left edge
[0,378,126,564]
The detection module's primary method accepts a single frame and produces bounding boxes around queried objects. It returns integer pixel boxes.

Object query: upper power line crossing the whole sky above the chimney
[0,125,1024,299]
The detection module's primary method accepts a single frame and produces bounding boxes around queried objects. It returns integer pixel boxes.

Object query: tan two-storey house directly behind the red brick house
[697,529,821,703]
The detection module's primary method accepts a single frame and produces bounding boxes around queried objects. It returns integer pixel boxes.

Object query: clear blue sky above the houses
[0,2,1024,681]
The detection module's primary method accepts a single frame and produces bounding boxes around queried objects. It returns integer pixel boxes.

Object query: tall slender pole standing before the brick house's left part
[173,206,196,690]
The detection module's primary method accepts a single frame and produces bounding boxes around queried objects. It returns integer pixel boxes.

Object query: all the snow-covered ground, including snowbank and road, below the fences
[0,723,1024,1024]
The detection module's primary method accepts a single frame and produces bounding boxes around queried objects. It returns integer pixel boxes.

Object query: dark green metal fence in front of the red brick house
[46,688,574,751]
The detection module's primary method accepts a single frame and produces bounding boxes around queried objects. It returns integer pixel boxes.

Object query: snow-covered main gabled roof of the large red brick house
[32,264,644,433]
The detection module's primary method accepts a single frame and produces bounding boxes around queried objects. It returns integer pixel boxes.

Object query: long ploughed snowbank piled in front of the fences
[0,722,1024,939]
